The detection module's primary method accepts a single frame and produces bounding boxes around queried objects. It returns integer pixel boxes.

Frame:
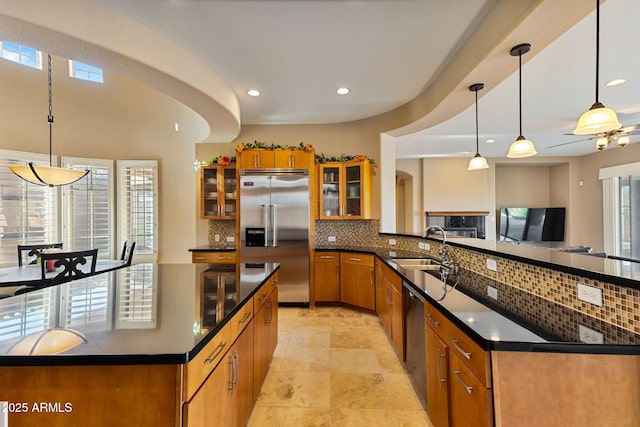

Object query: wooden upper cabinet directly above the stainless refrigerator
[237,148,314,169]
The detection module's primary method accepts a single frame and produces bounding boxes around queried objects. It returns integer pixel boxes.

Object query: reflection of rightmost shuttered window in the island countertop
[116,264,158,329]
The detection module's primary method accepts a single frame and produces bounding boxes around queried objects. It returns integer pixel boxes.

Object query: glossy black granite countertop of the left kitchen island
[0,263,279,366]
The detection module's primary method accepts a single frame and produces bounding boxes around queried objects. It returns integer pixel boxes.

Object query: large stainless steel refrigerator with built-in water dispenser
[240,169,310,305]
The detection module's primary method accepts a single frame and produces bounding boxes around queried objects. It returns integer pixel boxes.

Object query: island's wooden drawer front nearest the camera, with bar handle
[183,323,233,401]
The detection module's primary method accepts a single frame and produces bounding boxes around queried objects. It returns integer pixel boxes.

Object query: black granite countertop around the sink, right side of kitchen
[316,246,640,355]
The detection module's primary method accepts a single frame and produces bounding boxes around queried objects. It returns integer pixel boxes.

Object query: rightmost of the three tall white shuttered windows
[117,160,158,262]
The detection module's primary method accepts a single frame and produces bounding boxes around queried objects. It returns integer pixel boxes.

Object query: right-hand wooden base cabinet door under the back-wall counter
[340,252,376,310]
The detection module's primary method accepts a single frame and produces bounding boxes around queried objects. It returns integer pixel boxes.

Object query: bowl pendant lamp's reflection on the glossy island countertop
[7,328,87,356]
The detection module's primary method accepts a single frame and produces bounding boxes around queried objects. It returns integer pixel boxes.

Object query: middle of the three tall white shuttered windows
[62,157,114,259]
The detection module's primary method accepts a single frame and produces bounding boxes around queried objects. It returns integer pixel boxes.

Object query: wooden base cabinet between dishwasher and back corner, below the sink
[375,259,405,360]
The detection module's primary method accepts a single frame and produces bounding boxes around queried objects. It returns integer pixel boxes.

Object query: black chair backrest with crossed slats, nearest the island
[40,249,98,284]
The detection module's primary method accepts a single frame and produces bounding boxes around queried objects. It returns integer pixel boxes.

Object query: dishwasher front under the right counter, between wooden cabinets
[402,281,427,407]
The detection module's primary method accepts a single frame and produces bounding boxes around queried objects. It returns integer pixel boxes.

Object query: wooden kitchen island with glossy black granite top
[0,263,279,427]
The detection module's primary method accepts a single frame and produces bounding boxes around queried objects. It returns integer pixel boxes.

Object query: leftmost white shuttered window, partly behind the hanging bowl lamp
[0,150,60,267]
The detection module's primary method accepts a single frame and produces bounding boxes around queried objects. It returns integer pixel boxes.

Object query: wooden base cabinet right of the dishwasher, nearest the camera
[424,302,493,427]
